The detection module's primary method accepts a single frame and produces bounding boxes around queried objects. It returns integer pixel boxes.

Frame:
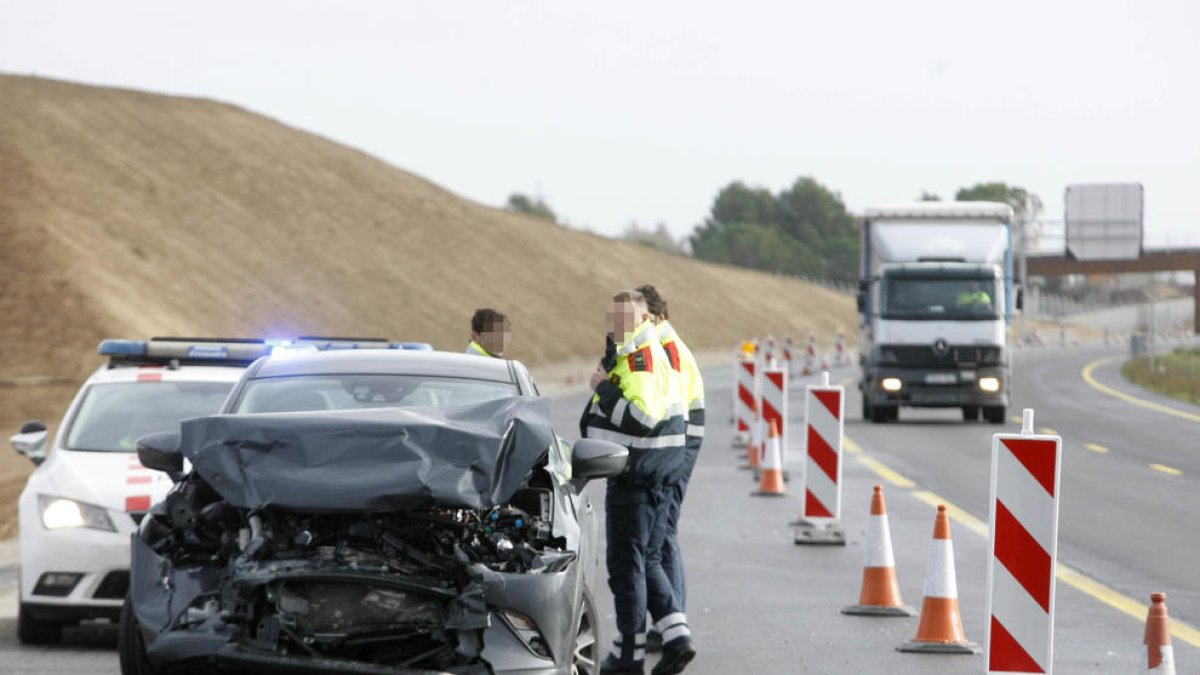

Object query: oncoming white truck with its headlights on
[858,202,1020,424]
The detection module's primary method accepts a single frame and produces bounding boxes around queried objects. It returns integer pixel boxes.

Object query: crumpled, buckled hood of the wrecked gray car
[180,396,554,513]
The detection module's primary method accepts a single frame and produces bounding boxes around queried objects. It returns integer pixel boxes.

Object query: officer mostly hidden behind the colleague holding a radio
[637,285,704,651]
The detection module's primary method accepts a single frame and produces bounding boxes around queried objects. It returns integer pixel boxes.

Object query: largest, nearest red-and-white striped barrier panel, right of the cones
[985,408,1062,674]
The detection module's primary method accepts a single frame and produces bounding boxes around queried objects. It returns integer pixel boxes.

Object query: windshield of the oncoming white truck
[882,276,1001,321]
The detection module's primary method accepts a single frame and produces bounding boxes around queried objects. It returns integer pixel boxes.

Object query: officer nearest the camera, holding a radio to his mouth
[583,291,696,675]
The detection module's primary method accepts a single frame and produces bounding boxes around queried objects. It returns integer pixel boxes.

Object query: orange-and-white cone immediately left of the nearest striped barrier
[896,504,983,653]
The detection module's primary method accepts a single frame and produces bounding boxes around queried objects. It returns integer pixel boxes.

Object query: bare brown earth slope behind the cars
[0,76,853,533]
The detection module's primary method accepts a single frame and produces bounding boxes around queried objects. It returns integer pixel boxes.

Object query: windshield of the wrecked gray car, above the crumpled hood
[233,375,520,413]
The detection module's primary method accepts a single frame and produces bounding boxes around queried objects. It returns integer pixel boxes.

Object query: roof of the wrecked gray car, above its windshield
[248,350,524,383]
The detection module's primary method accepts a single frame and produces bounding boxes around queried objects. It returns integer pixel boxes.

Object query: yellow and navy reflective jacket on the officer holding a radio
[584,321,686,485]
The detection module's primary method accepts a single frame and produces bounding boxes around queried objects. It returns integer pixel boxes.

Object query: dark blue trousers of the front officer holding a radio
[605,482,680,662]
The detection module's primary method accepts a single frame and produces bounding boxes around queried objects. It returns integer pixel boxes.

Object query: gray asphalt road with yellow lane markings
[0,347,1200,675]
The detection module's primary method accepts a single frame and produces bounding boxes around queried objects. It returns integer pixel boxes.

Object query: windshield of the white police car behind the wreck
[66,382,233,452]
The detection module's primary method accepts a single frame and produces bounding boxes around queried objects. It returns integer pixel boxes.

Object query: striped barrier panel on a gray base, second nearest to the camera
[792,372,846,545]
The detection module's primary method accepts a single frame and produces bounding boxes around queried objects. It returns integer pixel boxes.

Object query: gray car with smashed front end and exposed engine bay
[119,351,626,675]
